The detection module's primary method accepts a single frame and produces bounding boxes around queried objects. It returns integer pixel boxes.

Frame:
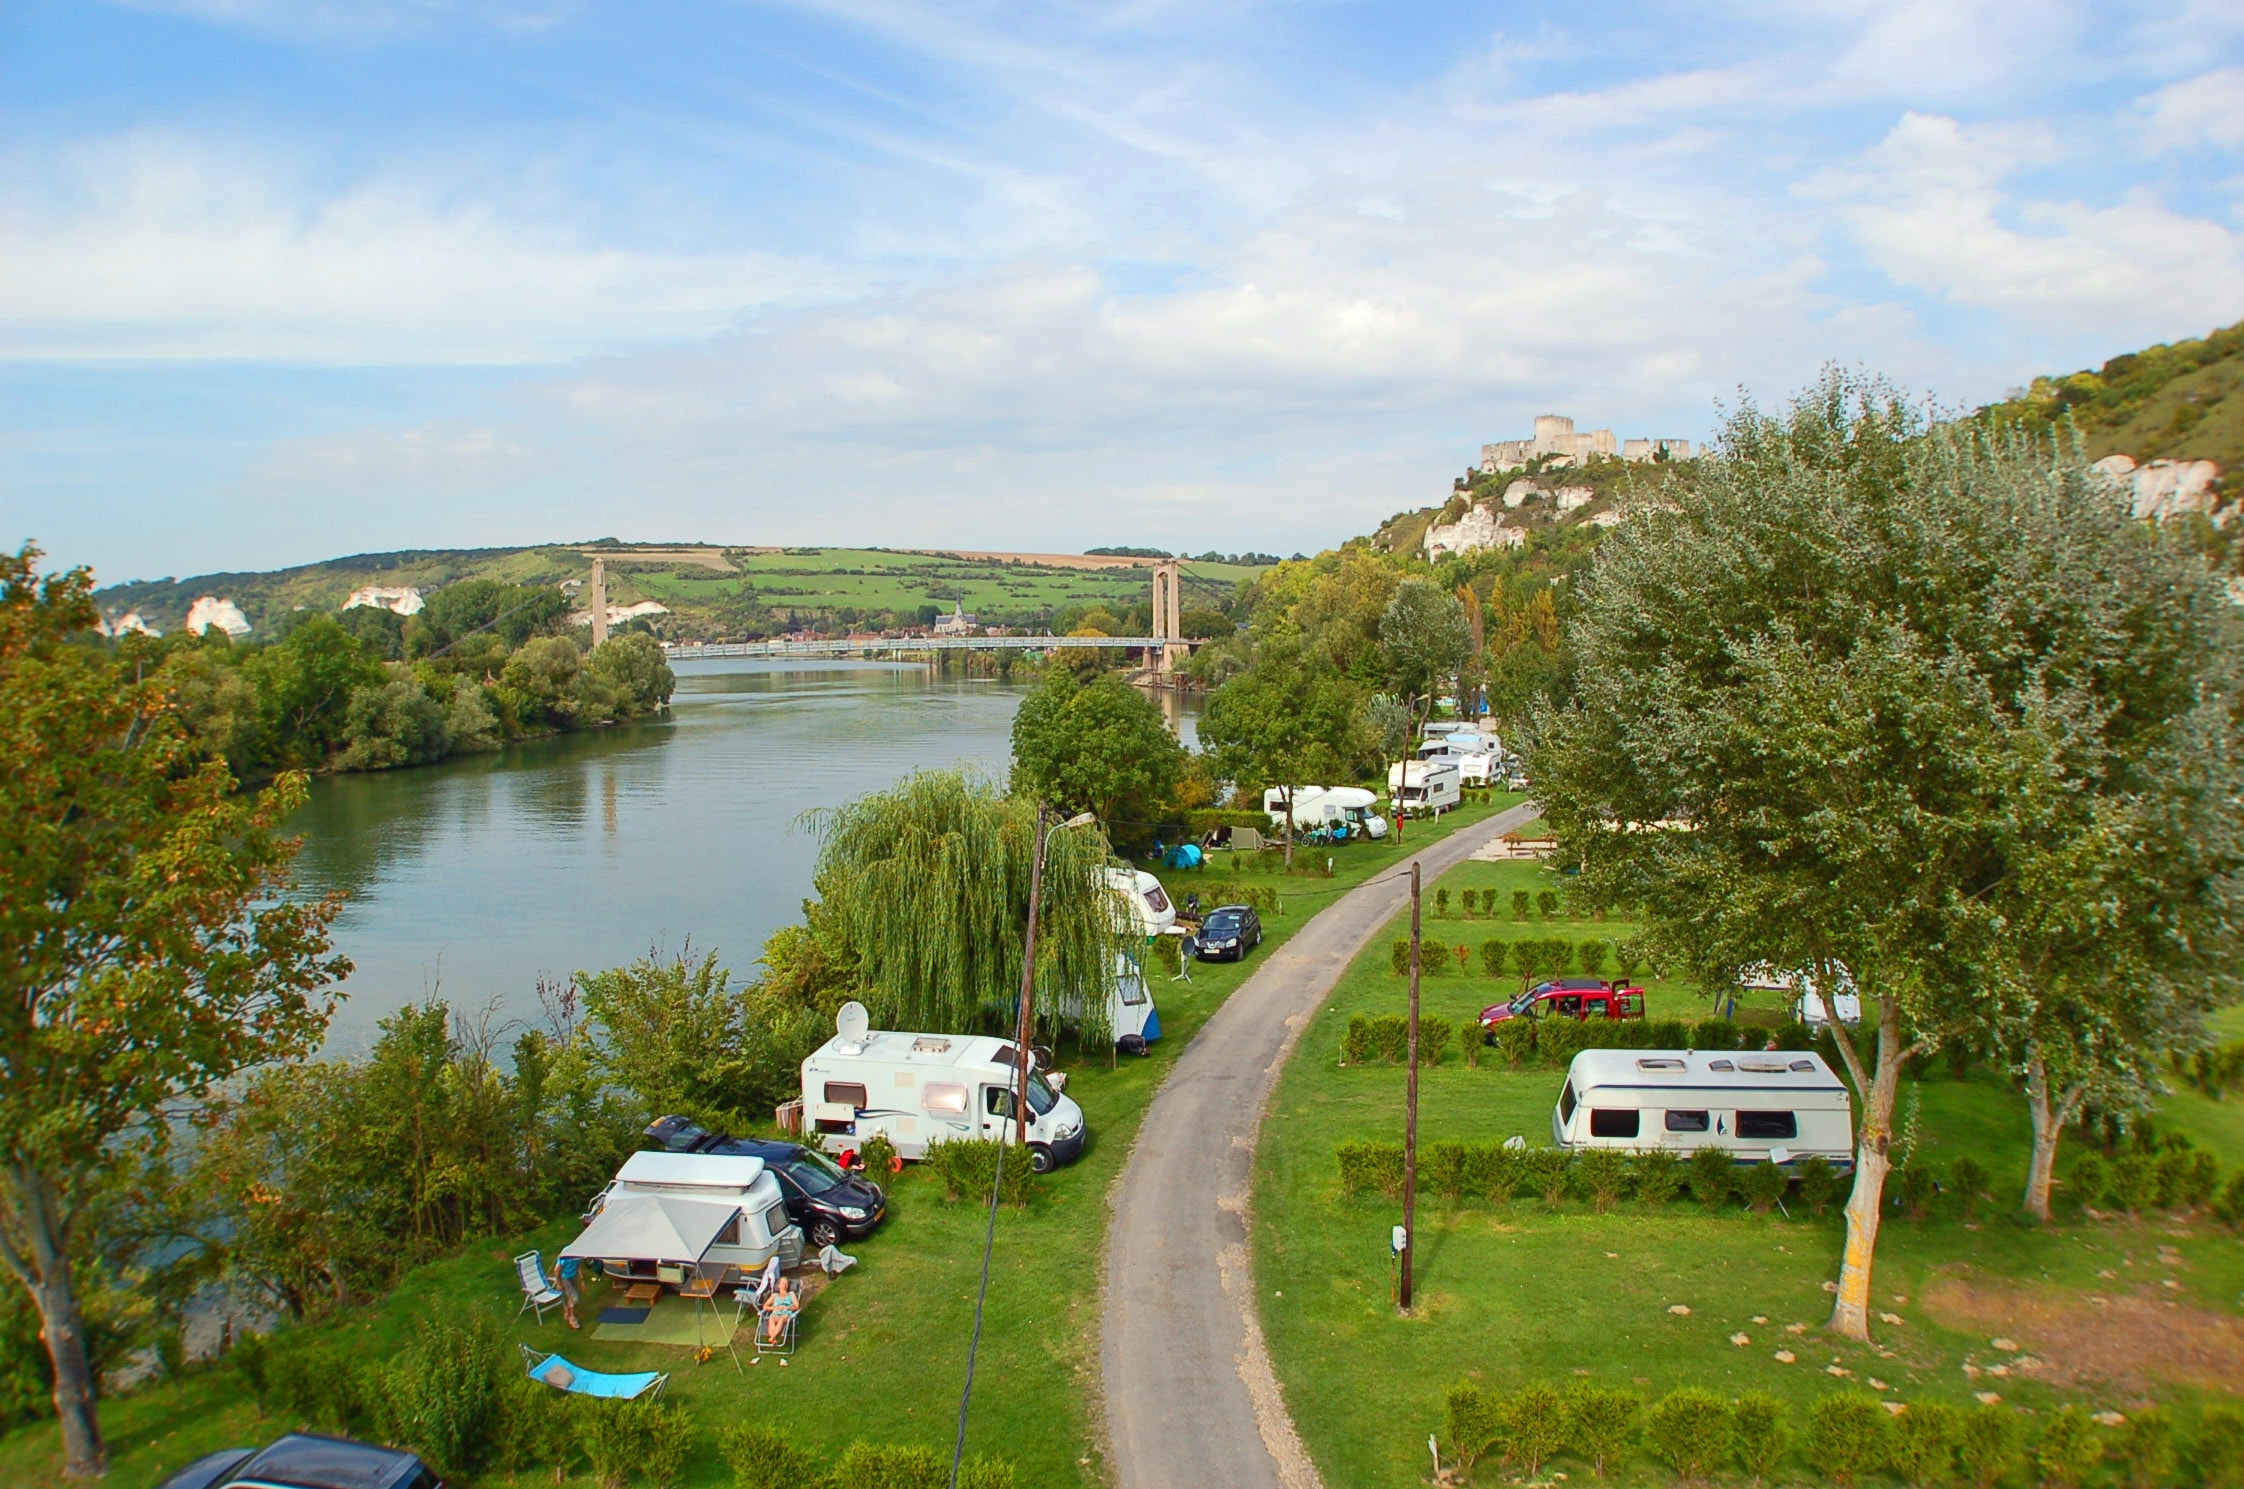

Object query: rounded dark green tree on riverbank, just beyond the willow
[1012,666,1185,836]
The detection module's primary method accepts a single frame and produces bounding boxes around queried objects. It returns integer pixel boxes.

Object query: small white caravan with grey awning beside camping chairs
[561,1153,803,1283]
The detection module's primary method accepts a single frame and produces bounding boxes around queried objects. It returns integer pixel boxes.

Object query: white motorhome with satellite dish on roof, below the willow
[803,1002,1084,1173]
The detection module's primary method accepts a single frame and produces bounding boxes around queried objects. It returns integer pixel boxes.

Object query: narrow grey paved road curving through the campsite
[1102,805,1535,1489]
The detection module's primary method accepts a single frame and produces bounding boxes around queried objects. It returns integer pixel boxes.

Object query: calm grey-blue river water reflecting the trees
[292,662,1194,1054]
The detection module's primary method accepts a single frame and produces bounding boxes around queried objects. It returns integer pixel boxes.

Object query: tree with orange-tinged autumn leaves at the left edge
[0,545,350,1476]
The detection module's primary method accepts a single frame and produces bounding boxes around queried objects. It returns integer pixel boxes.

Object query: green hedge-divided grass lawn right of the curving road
[1254,863,2244,1489]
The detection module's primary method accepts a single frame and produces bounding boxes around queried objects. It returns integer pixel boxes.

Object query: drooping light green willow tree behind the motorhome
[812,771,1129,1045]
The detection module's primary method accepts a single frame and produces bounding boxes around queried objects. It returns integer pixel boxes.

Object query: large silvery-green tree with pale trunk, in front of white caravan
[1535,372,2231,1337]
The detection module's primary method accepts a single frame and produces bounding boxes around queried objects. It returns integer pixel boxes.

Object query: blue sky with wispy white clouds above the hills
[0,0,2244,581]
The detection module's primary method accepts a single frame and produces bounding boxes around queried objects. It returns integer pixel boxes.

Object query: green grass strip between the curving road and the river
[0,794,1515,1489]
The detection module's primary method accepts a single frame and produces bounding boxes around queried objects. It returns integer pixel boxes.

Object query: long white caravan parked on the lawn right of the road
[1551,1049,1854,1166]
